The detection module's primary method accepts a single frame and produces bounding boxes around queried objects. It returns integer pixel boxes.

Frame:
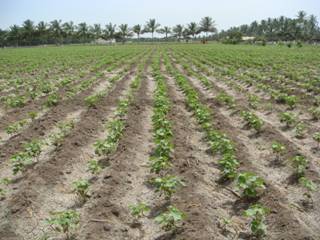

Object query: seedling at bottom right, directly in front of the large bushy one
[244,204,270,238]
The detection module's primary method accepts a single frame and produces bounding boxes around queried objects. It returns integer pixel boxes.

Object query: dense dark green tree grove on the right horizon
[217,11,320,42]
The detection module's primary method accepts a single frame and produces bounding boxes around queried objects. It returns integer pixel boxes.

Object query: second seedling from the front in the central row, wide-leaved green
[151,176,185,199]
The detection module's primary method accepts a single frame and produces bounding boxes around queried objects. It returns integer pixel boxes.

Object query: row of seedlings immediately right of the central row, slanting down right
[164,52,269,237]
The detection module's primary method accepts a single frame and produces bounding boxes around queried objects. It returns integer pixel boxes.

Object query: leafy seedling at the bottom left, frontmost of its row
[47,210,80,240]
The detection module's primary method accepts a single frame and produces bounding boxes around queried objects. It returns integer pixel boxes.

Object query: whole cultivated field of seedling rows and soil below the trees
[0,43,320,240]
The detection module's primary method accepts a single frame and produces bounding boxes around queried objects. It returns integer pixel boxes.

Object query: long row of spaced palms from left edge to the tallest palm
[0,17,217,46]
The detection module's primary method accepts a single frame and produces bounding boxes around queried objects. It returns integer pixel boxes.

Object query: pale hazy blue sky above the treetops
[0,0,320,30]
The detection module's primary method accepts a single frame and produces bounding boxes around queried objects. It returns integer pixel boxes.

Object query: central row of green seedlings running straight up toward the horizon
[129,53,186,233]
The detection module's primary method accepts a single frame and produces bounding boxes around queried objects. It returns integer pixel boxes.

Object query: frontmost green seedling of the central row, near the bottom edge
[155,206,186,231]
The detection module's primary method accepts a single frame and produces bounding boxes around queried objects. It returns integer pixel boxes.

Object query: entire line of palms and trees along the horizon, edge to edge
[0,11,320,47]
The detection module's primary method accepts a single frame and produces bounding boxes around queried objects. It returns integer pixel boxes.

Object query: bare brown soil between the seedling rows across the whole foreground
[0,47,320,240]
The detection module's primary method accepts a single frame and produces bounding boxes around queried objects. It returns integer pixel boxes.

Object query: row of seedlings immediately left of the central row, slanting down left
[43,54,149,239]
